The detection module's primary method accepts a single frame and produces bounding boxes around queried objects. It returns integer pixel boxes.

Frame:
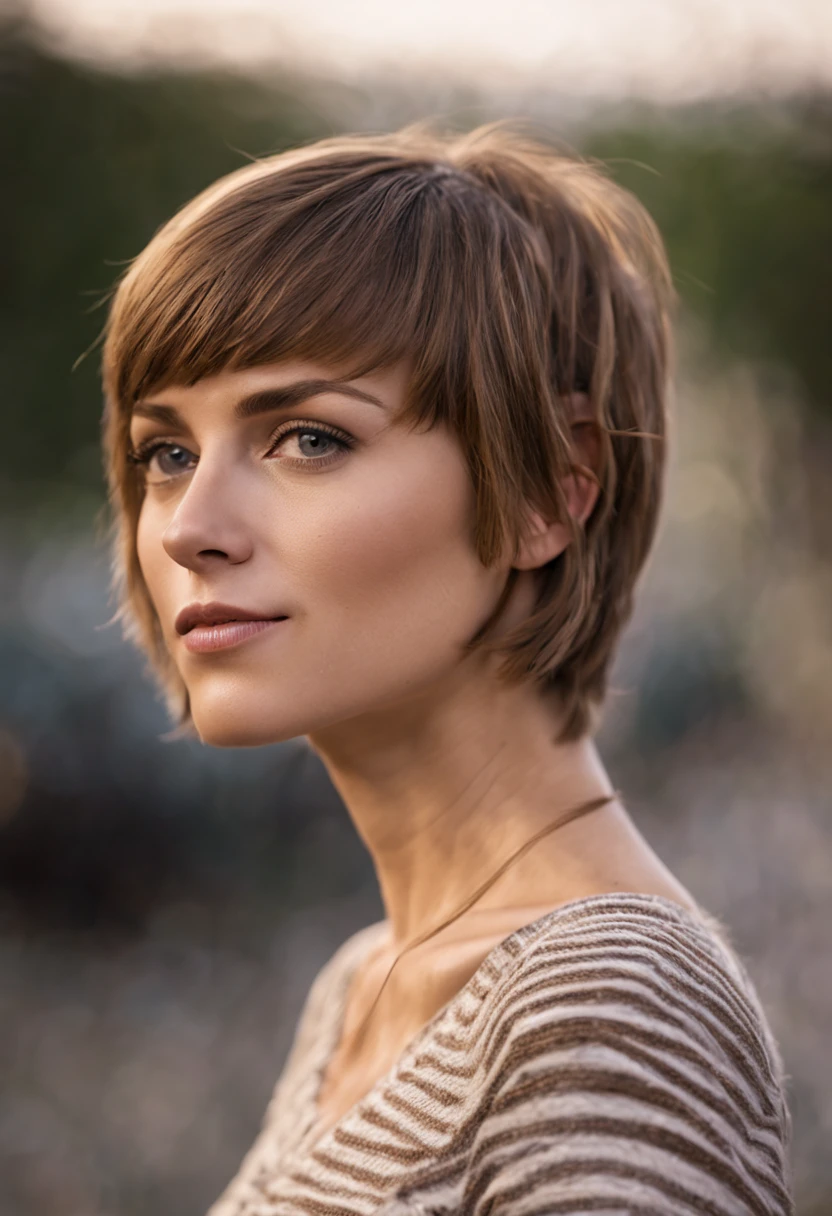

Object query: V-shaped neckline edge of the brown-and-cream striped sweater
[289,891,730,1164]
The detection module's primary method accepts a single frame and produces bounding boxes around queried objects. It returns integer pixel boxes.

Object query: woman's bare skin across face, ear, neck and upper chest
[131,362,696,1131]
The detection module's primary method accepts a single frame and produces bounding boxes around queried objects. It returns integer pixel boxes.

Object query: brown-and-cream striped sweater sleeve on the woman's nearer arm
[462,918,793,1216]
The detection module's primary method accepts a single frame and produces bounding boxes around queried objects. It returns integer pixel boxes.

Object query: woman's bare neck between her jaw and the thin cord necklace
[309,665,612,947]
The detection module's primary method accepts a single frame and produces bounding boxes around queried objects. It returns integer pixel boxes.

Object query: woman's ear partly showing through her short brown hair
[512,393,601,570]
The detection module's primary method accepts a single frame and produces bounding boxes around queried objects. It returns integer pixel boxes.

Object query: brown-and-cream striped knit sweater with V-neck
[208,894,794,1216]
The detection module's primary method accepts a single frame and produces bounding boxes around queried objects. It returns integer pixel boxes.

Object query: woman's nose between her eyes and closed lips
[162,460,252,573]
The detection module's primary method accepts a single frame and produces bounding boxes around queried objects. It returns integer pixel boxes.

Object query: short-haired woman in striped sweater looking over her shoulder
[103,128,792,1216]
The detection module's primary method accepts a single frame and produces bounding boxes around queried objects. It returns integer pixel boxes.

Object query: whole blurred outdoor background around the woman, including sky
[0,0,832,1216]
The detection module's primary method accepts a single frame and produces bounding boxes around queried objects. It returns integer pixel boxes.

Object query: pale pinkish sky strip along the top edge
[30,0,832,101]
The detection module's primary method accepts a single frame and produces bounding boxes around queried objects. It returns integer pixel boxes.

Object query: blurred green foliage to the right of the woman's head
[583,110,832,412]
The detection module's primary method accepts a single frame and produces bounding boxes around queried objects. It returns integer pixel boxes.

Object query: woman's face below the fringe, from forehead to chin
[130,362,508,747]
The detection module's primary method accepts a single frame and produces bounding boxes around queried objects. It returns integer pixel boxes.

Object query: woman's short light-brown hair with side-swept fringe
[102,126,674,739]
